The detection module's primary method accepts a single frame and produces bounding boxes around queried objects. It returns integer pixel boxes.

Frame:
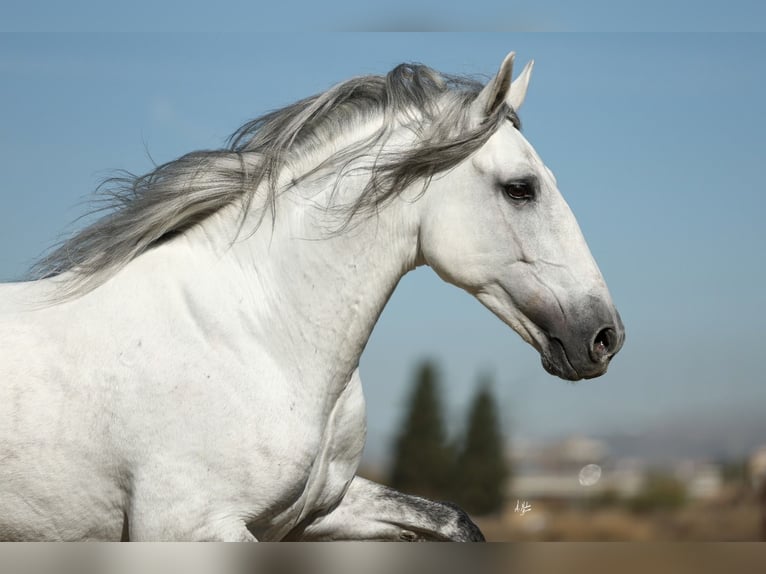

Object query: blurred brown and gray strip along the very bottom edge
[0,542,766,574]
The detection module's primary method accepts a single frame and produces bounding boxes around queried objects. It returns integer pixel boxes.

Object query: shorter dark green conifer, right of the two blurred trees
[452,377,510,514]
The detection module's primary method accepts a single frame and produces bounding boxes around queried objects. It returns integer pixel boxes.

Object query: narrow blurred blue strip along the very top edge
[0,0,766,31]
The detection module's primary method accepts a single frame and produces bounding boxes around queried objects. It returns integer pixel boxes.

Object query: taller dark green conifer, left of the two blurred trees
[390,361,452,499]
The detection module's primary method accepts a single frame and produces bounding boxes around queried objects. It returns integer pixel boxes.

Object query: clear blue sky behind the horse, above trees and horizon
[0,33,766,466]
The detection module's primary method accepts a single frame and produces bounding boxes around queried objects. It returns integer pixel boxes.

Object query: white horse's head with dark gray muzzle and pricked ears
[420,53,625,381]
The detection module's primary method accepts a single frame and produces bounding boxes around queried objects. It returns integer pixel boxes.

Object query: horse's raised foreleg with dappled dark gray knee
[289,476,484,542]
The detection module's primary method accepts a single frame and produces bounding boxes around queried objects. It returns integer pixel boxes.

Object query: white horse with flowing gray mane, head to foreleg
[0,54,623,541]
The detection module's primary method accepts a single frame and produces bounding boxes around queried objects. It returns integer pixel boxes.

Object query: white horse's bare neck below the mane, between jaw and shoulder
[183,156,419,383]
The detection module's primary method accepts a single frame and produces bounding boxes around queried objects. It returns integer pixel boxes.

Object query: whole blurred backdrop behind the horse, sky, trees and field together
[0,33,766,540]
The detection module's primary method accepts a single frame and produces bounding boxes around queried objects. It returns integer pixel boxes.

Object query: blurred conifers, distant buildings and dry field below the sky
[360,361,766,541]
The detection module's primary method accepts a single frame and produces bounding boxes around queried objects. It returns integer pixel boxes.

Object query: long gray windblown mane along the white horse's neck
[32,64,519,295]
